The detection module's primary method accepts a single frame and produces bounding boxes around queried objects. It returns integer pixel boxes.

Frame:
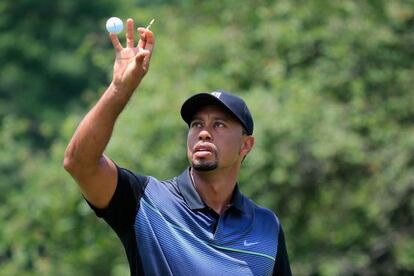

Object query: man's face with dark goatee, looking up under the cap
[187,105,253,171]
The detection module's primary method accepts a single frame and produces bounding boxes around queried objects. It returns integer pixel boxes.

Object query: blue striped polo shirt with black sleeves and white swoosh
[91,165,291,276]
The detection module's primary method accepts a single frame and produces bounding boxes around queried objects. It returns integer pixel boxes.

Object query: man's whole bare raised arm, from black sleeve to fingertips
[64,19,155,208]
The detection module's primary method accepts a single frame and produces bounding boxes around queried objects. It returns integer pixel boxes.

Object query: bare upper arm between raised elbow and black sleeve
[73,155,118,209]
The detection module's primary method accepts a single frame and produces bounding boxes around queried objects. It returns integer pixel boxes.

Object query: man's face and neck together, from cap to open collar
[187,106,254,214]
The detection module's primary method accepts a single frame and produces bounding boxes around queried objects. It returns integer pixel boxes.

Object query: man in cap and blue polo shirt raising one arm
[64,19,291,275]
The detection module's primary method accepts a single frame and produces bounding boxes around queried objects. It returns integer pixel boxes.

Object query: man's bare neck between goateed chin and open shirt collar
[190,168,238,214]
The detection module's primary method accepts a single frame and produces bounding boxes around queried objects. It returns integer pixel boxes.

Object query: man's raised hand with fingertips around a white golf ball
[109,18,155,92]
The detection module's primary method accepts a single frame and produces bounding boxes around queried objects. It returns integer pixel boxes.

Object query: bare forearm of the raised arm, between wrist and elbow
[64,84,133,175]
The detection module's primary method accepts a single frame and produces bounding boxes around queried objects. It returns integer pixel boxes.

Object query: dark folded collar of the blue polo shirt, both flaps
[177,168,245,212]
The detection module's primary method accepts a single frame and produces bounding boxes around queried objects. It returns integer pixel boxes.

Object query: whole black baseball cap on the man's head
[181,90,253,135]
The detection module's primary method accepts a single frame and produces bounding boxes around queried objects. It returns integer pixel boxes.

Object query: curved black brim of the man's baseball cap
[181,93,237,125]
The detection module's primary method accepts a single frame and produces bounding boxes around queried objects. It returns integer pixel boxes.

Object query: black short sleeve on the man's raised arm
[88,166,148,237]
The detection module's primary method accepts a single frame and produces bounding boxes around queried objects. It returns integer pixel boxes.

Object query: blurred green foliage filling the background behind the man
[0,0,414,275]
